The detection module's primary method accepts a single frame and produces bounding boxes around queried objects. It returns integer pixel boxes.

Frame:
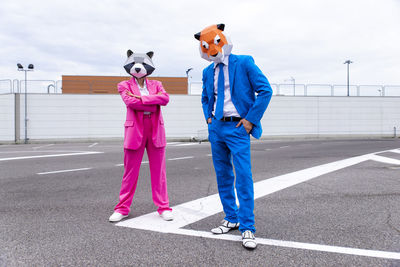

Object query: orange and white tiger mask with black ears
[194,24,232,63]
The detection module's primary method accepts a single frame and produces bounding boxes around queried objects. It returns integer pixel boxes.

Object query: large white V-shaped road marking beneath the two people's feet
[116,151,400,259]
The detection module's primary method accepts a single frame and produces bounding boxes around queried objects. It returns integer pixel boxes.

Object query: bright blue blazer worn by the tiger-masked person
[201,54,272,139]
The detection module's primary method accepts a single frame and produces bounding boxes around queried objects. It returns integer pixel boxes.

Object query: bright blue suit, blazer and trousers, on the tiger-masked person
[201,54,272,232]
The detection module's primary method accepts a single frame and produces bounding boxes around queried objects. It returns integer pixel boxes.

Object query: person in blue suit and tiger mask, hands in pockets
[195,24,272,249]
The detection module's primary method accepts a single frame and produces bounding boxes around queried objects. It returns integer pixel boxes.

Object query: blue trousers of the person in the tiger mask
[208,118,256,232]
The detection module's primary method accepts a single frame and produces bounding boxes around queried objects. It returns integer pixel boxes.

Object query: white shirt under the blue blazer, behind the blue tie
[212,56,240,117]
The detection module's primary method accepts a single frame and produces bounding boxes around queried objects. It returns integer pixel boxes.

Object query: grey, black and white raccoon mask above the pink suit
[124,50,155,78]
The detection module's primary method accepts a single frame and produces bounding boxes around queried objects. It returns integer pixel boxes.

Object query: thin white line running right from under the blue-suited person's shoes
[173,229,400,260]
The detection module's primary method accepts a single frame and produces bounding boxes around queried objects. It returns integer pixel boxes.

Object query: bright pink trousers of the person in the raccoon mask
[114,115,171,215]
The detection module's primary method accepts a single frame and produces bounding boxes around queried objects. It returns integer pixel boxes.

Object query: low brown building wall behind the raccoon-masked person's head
[62,75,188,94]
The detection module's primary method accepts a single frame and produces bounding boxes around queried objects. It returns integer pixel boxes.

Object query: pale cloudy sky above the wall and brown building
[0,0,400,87]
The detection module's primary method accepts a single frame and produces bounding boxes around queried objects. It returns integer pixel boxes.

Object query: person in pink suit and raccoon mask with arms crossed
[109,50,173,222]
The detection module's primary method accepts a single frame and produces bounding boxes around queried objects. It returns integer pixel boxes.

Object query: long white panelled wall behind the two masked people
[0,94,400,142]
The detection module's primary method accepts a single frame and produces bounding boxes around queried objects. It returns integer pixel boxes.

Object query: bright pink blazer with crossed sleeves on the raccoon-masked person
[118,78,169,149]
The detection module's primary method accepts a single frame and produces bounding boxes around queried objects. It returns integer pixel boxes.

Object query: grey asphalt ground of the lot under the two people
[0,139,400,267]
